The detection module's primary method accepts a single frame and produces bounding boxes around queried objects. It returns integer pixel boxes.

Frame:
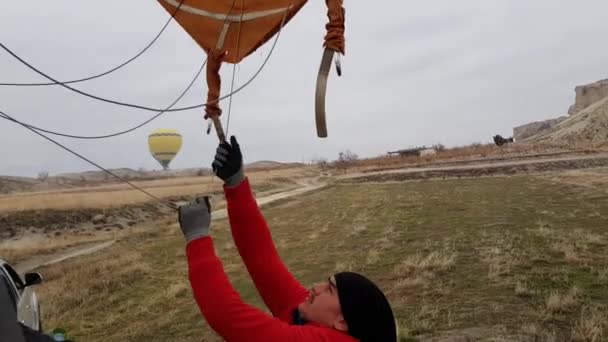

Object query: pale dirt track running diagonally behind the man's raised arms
[15,183,325,274]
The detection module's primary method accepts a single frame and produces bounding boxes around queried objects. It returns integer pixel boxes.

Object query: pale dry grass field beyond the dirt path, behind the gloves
[0,167,318,263]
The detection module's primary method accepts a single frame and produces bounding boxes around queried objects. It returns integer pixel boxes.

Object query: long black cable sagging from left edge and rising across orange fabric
[0,9,287,112]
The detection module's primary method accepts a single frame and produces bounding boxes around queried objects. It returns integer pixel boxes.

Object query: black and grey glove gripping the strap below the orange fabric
[211,136,245,187]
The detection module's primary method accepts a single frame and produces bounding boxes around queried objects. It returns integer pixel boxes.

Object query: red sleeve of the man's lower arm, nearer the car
[186,237,355,342]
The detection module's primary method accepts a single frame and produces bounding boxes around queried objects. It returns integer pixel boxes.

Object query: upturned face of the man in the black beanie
[298,277,348,331]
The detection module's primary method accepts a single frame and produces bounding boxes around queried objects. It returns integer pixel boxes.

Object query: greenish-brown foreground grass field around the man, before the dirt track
[28,175,608,342]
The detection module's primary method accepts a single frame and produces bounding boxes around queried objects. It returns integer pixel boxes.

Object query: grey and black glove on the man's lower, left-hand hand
[178,196,211,242]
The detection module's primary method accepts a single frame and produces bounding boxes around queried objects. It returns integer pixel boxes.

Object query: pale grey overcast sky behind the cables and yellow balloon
[0,0,608,176]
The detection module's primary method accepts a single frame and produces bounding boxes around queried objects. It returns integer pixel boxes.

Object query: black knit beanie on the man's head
[335,272,397,342]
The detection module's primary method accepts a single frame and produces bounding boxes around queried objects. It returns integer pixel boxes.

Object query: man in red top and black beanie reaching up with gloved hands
[179,137,397,342]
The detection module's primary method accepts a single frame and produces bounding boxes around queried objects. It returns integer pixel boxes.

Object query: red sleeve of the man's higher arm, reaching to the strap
[224,179,308,316]
